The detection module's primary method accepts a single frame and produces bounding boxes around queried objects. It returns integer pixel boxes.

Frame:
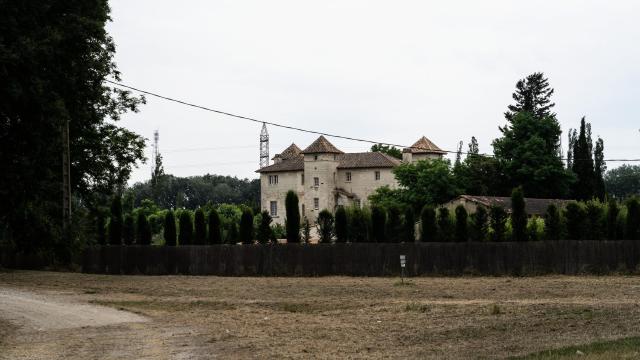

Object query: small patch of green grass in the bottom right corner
[509,337,640,360]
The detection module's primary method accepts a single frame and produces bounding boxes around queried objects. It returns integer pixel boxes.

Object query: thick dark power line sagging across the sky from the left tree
[104,79,640,162]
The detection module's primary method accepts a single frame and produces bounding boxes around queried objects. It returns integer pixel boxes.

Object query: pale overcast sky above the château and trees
[108,0,640,186]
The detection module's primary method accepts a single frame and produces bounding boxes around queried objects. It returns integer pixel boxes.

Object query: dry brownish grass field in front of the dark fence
[0,271,640,359]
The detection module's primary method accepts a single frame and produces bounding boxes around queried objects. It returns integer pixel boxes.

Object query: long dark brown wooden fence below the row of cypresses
[82,241,640,276]
